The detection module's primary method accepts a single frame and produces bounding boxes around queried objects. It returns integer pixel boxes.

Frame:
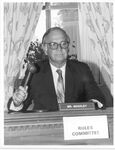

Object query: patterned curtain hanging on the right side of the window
[78,3,113,92]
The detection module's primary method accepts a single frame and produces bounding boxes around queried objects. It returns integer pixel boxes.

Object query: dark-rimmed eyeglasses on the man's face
[47,41,69,50]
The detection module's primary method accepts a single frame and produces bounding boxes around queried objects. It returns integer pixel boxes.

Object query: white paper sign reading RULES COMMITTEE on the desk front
[63,115,109,140]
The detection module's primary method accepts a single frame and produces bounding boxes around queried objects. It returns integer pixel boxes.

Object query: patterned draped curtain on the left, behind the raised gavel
[4,3,42,109]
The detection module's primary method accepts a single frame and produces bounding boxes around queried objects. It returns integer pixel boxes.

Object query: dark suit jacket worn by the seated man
[8,60,105,111]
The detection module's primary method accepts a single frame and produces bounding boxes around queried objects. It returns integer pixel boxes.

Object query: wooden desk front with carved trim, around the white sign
[4,108,113,145]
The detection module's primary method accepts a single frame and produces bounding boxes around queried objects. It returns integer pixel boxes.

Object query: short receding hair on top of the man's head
[42,27,70,44]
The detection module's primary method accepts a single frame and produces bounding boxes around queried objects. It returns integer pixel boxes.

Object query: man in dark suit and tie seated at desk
[8,27,105,111]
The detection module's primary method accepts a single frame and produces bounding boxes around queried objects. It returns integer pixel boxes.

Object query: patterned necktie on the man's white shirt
[56,69,65,103]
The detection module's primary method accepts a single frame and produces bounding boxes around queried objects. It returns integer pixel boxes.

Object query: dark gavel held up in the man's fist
[22,63,37,87]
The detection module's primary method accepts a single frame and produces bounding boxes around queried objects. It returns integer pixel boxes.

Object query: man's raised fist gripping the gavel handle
[13,86,28,107]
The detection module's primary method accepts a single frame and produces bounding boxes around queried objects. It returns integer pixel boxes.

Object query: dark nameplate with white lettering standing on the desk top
[59,102,95,111]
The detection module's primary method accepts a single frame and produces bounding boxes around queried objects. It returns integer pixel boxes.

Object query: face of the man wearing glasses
[45,30,69,66]
